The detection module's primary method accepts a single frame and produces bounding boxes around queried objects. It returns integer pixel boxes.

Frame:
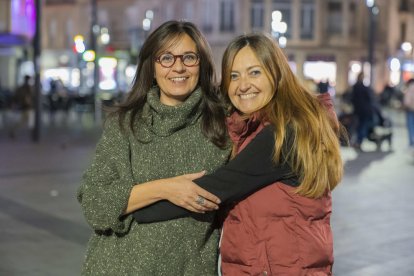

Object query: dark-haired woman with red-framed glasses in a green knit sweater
[77,21,230,276]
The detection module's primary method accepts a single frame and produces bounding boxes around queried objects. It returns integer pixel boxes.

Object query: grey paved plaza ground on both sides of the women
[0,109,414,276]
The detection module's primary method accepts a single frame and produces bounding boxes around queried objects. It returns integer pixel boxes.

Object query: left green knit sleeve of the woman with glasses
[77,117,134,233]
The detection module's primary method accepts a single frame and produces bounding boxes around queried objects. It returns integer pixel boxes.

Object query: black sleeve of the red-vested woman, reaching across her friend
[133,126,297,223]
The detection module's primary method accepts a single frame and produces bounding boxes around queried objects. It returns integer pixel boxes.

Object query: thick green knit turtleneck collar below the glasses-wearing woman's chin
[137,87,202,142]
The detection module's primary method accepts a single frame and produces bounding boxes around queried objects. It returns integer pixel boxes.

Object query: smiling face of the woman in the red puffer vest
[227,46,274,114]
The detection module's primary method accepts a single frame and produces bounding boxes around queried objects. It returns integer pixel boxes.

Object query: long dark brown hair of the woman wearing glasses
[115,20,227,148]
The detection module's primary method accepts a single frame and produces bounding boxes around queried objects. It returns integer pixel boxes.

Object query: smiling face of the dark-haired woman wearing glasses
[155,34,200,106]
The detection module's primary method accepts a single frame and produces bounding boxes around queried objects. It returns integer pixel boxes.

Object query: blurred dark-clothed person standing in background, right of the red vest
[351,72,375,151]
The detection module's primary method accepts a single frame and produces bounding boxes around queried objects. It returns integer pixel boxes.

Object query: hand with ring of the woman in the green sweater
[163,171,220,213]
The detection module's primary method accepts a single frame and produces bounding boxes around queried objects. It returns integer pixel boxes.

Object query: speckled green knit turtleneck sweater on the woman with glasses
[77,89,230,276]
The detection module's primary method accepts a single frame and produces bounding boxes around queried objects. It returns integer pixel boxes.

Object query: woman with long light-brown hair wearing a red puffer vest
[134,33,343,276]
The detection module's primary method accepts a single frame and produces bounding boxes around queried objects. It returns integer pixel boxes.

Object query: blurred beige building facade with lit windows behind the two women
[0,0,414,93]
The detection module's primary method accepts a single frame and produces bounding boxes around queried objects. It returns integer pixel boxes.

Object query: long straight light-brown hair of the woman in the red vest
[221,33,343,198]
